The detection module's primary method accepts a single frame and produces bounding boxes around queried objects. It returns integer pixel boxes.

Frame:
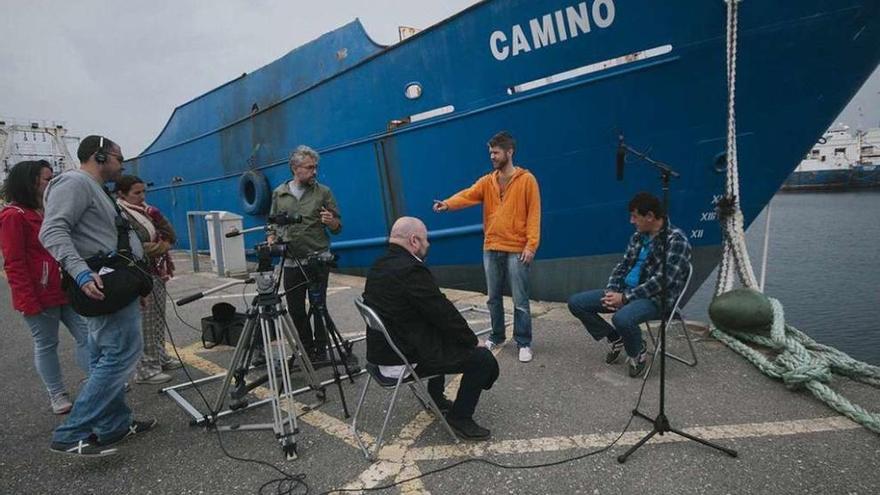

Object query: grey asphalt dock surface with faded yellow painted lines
[0,257,880,494]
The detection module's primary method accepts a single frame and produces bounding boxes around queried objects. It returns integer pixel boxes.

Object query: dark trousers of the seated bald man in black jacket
[416,347,498,418]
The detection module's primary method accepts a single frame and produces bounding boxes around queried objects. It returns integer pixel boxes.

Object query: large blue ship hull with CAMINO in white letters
[128,0,880,300]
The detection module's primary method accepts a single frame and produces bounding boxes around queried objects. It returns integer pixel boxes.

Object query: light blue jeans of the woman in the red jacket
[24,304,90,395]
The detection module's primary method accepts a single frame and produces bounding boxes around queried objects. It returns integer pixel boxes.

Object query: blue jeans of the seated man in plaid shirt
[568,289,660,358]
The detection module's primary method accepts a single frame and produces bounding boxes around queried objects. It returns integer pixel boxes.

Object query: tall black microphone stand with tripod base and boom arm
[617,138,738,464]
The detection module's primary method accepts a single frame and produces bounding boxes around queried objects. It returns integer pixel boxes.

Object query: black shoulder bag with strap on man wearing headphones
[62,194,153,316]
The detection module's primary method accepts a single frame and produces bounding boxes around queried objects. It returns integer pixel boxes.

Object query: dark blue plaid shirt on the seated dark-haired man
[606,224,691,309]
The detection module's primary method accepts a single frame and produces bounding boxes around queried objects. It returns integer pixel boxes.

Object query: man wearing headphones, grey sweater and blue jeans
[40,136,156,456]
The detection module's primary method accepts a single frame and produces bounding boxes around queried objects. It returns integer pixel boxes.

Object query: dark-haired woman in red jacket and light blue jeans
[0,160,90,414]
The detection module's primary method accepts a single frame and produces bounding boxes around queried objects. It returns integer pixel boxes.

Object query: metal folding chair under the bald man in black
[351,297,459,460]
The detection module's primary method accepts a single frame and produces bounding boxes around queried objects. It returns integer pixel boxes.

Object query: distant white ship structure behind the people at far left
[0,118,80,181]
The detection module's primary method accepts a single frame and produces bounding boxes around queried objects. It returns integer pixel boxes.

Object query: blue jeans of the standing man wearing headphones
[52,299,144,443]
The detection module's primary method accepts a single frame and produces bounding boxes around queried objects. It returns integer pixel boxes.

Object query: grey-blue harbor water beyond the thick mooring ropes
[685,191,880,365]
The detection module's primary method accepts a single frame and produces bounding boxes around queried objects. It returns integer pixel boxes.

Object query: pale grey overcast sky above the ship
[0,0,880,156]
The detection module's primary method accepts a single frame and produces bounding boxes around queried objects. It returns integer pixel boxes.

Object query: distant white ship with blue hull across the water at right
[782,124,880,191]
